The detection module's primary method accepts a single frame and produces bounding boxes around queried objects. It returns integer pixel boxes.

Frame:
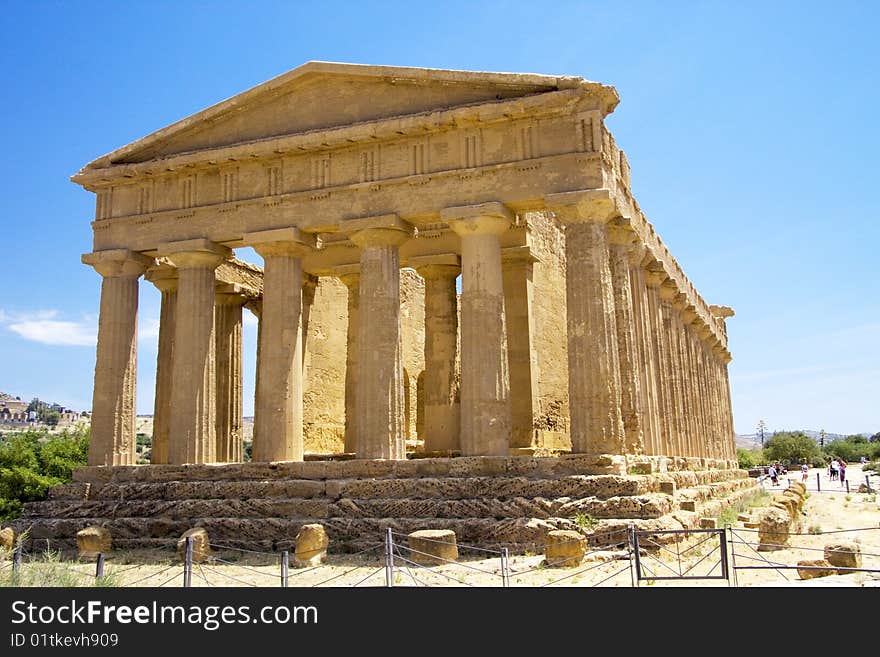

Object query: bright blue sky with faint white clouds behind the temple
[0,0,880,433]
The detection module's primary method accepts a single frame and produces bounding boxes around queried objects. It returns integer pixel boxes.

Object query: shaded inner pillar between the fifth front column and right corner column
[501,246,539,447]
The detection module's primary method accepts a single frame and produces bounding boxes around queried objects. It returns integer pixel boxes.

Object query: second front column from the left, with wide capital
[159,239,232,464]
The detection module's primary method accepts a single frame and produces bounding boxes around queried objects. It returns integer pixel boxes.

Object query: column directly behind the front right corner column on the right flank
[608,224,645,454]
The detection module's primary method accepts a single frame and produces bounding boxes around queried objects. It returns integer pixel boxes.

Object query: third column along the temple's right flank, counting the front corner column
[630,249,664,455]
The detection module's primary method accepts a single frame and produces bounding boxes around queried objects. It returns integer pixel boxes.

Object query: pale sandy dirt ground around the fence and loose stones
[0,465,880,587]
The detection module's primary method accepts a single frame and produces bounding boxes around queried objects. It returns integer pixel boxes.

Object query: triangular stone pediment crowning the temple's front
[86,62,572,168]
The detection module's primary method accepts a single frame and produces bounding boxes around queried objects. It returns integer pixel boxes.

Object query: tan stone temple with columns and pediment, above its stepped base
[72,62,736,467]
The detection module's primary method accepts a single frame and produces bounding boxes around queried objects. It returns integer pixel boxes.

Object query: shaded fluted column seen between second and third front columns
[214,284,247,463]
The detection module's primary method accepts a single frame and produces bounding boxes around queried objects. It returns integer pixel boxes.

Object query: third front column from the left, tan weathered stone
[243,228,315,461]
